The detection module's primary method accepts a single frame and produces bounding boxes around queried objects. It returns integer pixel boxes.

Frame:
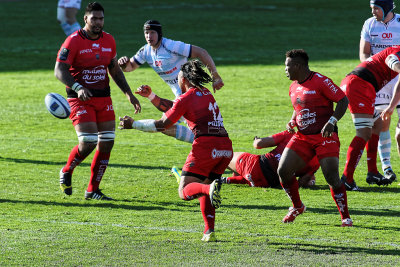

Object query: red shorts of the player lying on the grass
[236,153,269,187]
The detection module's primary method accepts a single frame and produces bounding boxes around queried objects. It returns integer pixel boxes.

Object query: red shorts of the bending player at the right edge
[340,75,376,115]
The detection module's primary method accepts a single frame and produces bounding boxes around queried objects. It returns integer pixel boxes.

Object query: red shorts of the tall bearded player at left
[68,96,115,126]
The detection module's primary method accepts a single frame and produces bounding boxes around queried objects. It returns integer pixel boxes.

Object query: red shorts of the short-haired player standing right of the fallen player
[286,132,340,162]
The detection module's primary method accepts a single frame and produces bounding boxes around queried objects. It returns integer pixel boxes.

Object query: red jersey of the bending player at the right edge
[350,46,400,91]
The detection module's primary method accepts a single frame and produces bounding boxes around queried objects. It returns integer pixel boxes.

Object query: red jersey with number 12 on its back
[165,87,228,138]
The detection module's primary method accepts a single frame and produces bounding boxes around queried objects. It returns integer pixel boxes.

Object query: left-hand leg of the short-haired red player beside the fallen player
[278,146,306,223]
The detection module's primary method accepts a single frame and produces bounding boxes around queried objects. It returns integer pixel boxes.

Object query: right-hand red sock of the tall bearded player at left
[87,150,110,192]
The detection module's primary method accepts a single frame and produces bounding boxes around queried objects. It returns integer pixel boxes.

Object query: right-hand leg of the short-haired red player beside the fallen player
[320,157,352,226]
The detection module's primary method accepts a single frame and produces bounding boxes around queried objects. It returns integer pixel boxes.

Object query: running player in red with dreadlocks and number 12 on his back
[119,60,233,242]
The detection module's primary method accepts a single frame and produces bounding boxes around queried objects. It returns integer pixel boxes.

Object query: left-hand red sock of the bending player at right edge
[343,136,367,183]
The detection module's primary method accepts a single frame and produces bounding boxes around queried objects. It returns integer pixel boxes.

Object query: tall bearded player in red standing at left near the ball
[54,2,141,200]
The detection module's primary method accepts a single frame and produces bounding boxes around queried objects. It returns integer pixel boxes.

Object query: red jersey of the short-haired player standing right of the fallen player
[289,72,345,135]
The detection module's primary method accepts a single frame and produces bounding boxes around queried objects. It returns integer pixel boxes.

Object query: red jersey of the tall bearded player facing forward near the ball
[57,29,117,97]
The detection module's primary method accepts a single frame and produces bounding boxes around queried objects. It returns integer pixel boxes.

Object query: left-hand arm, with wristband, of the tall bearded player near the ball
[54,61,92,101]
